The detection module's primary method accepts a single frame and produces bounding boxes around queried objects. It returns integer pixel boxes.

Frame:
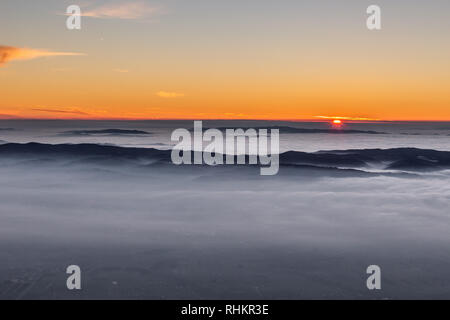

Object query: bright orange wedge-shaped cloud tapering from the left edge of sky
[0,45,85,67]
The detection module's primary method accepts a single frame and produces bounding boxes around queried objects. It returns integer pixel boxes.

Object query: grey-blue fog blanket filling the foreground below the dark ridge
[0,154,450,299]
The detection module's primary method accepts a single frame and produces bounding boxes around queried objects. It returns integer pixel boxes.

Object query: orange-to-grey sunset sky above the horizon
[0,0,450,121]
